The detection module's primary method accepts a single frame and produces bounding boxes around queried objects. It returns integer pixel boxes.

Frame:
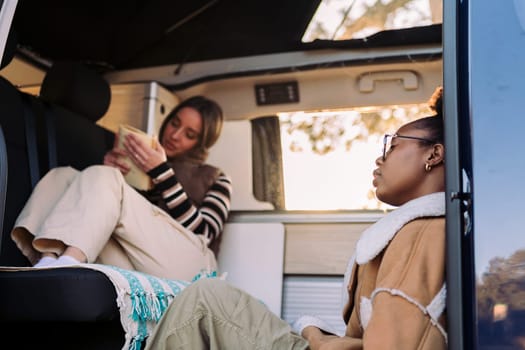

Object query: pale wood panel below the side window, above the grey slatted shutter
[284,223,372,275]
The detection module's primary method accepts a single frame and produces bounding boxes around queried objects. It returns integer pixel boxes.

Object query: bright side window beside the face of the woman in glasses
[279,104,430,210]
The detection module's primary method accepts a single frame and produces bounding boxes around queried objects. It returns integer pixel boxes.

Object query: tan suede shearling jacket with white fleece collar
[342,193,447,350]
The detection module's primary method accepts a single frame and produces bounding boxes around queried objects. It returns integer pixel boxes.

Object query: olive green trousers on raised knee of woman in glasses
[146,278,308,350]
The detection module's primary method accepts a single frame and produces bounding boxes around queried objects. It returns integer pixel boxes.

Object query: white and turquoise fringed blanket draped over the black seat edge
[1,264,217,350]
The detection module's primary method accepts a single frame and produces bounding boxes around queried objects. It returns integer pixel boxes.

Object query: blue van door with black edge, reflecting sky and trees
[443,0,525,349]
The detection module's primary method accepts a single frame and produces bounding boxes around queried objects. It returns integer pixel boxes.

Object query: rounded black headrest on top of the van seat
[40,61,111,122]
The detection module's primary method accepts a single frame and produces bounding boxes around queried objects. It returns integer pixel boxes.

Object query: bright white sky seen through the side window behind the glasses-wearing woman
[280,105,427,210]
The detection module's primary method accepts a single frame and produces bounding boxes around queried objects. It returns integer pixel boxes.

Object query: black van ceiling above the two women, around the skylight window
[13,0,441,72]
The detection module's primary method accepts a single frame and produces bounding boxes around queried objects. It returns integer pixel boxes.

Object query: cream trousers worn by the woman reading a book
[11,165,216,280]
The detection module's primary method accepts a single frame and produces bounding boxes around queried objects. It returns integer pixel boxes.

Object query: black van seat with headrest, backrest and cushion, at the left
[0,34,124,349]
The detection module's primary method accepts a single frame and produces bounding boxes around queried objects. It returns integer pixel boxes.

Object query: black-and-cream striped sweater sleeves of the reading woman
[148,162,232,243]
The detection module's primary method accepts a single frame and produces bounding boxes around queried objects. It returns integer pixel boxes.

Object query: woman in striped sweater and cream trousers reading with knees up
[11,96,231,280]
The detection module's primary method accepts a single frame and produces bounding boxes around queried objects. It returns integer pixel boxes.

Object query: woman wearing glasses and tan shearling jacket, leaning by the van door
[141,89,447,350]
